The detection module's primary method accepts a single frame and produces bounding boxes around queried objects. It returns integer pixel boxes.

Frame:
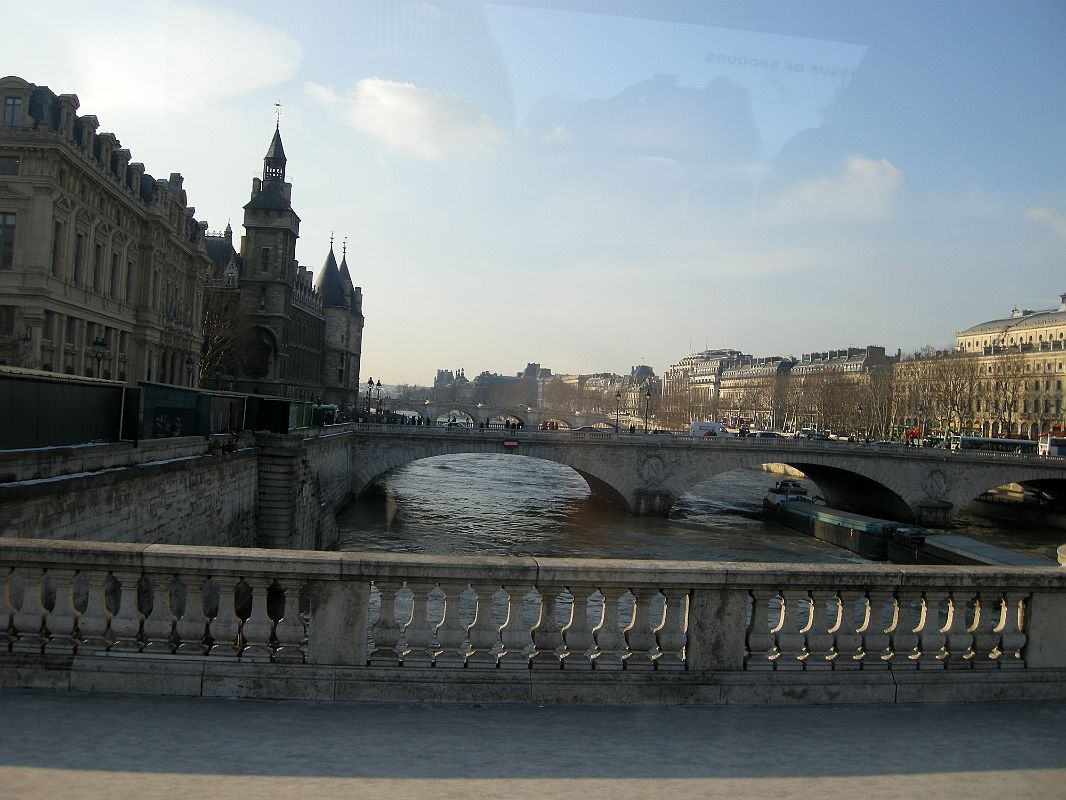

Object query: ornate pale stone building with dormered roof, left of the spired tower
[0,77,210,385]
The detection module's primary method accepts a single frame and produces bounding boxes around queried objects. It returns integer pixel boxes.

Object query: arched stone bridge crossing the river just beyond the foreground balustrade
[353,425,1066,527]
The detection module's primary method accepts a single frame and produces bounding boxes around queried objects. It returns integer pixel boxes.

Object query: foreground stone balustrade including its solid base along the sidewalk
[0,539,1066,702]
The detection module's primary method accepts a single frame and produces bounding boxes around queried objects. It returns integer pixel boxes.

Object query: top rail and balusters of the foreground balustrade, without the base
[0,539,1066,679]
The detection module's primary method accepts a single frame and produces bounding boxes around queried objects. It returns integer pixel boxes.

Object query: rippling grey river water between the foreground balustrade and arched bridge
[338,454,1066,563]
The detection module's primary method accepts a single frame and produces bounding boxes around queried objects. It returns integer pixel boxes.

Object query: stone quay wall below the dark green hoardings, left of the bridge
[0,426,353,549]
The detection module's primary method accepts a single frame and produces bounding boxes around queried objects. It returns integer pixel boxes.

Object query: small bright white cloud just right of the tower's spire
[304,78,507,159]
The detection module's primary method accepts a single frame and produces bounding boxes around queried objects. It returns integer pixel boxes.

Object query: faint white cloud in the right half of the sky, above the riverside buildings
[775,156,903,220]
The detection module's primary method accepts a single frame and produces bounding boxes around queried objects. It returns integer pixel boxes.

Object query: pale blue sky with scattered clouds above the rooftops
[0,0,1066,385]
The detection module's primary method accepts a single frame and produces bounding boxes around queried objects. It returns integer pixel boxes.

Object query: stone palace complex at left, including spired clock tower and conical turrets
[0,77,364,407]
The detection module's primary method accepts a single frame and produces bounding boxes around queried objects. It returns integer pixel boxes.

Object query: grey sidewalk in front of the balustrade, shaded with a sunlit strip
[0,690,1066,800]
